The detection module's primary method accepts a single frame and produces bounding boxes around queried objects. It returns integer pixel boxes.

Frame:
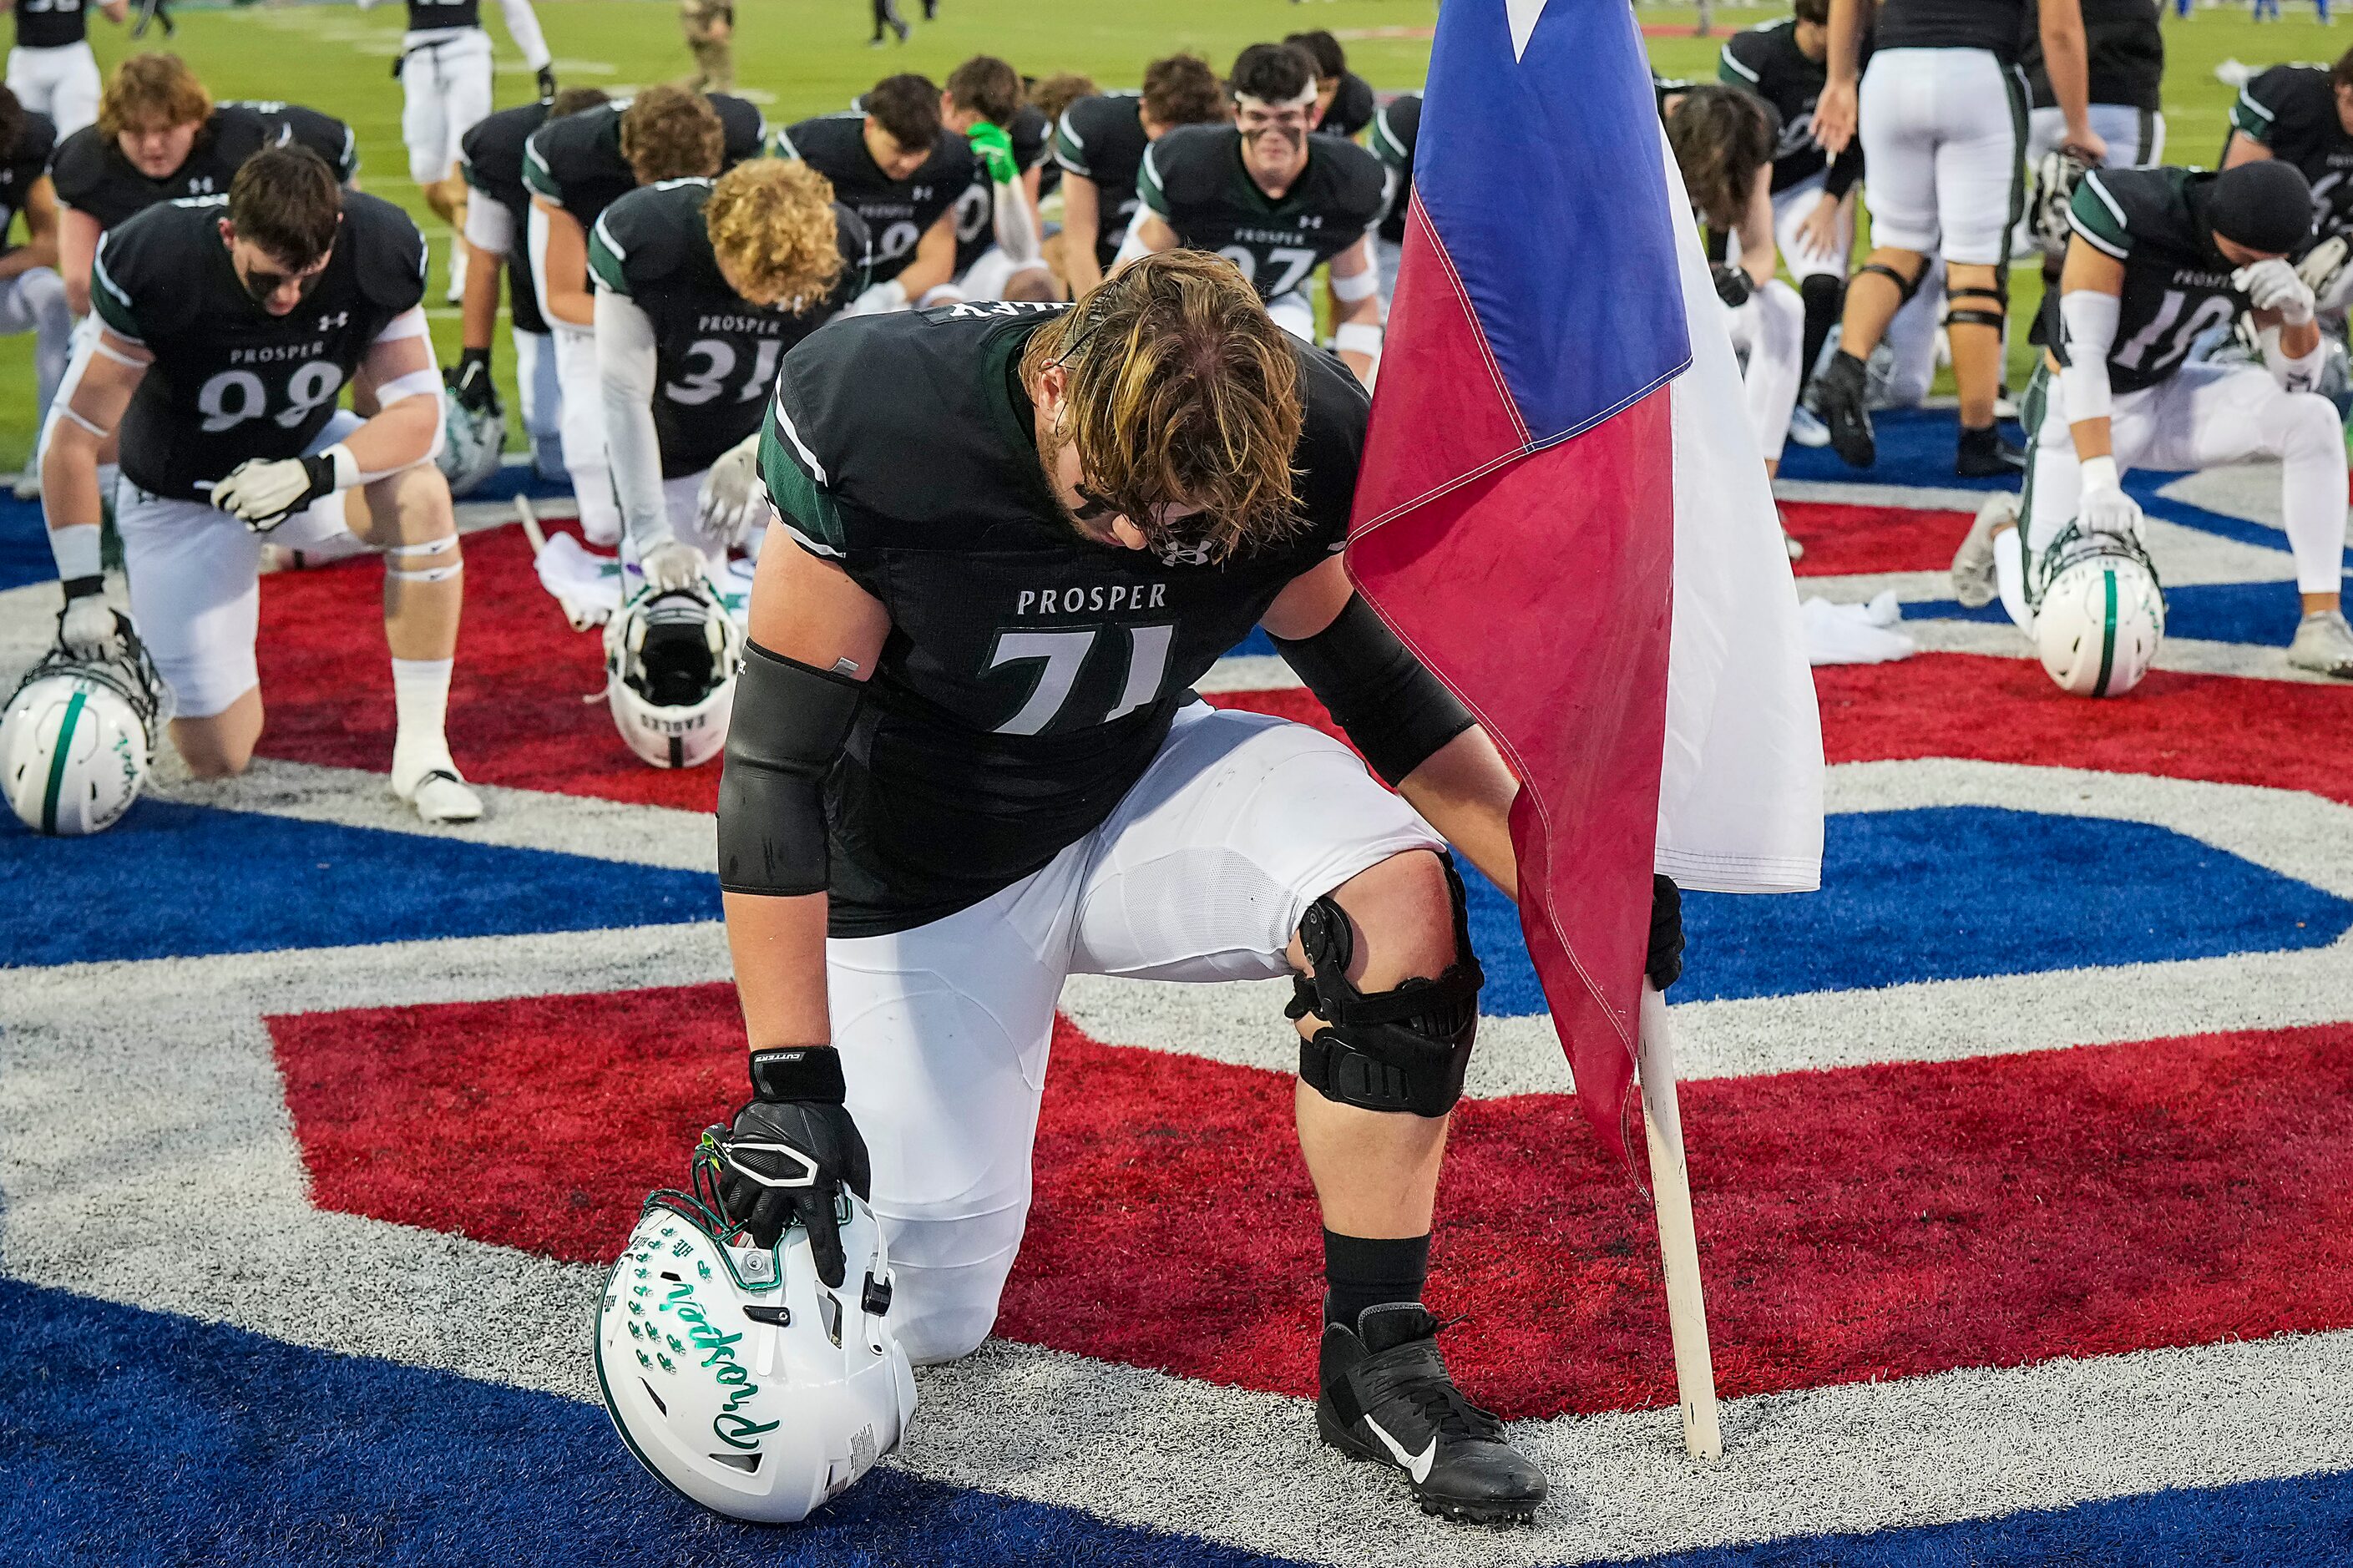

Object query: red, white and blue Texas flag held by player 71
[1349,0,1821,1158]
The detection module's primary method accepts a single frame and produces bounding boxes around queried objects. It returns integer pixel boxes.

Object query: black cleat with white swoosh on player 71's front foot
[1315,1302,1546,1523]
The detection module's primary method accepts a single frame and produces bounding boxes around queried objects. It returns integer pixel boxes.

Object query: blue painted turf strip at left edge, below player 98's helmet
[0,801,720,965]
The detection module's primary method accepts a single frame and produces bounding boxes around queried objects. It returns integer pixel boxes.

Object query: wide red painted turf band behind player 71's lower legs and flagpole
[271,987,2353,1418]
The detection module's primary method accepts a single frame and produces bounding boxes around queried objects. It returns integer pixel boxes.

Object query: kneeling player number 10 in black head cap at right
[1953,163,2353,678]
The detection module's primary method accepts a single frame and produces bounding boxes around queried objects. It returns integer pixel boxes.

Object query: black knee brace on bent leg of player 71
[1283,855,1487,1116]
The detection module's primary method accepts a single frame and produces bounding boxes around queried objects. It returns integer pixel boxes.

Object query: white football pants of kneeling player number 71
[826,704,1445,1361]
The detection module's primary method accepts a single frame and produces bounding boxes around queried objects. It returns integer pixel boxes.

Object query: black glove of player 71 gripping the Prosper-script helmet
[720,1045,873,1290]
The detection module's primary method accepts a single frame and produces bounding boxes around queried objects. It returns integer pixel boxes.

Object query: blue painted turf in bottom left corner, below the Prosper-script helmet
[0,1281,1275,1568]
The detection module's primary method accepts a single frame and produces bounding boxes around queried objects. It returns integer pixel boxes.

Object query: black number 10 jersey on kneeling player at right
[2042,169,2247,393]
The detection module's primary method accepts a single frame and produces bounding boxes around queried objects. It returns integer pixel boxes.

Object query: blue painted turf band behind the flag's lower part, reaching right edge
[1470,805,2353,1014]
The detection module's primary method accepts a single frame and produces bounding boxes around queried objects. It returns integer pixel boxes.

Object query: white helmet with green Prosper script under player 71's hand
[595,1149,915,1523]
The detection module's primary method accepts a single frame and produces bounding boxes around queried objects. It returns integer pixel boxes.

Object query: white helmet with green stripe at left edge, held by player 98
[0,612,164,836]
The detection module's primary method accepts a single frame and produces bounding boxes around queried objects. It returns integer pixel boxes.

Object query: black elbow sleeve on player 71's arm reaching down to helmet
[720,643,866,897]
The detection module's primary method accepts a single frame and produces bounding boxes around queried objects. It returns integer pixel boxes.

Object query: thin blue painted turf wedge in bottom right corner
[1628,1471,2353,1568]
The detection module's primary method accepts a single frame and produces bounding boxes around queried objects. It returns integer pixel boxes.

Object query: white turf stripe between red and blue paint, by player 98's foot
[153,739,717,876]
